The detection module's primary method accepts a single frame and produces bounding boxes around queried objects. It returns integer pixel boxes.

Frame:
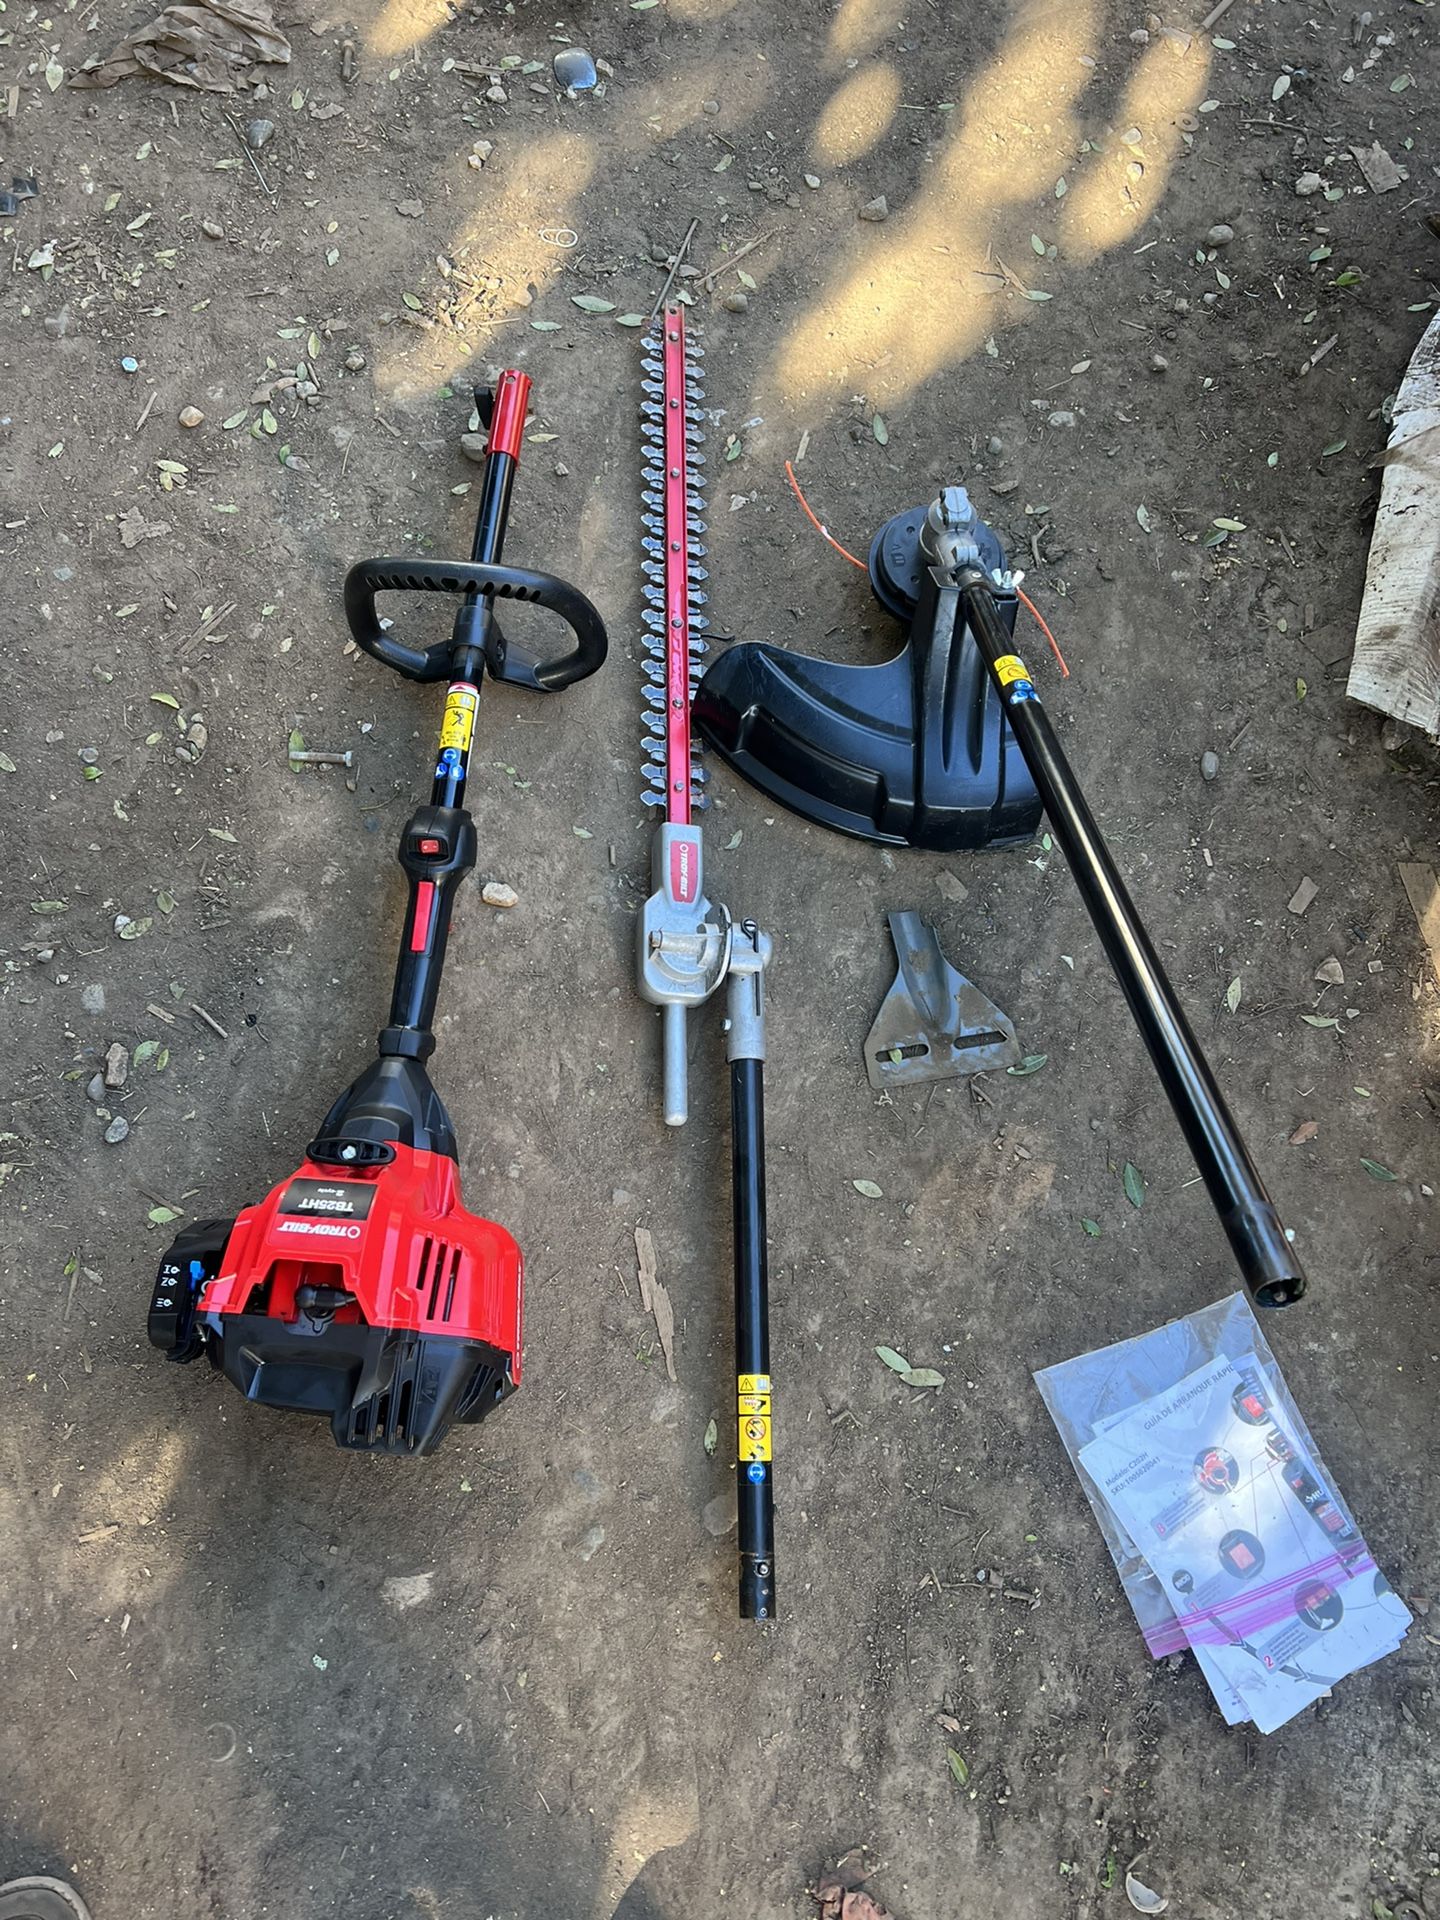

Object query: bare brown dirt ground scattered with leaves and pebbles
[0,0,1440,1920]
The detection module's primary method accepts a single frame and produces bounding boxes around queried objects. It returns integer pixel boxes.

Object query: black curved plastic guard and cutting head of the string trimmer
[695,503,1041,852]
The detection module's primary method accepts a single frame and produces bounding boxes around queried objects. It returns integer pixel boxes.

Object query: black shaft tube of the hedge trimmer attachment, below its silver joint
[730,1060,776,1620]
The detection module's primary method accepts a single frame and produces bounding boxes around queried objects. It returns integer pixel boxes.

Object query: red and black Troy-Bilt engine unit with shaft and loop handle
[150,371,605,1453]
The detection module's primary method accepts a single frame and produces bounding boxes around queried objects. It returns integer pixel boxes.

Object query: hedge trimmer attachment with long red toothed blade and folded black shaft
[639,305,776,1620]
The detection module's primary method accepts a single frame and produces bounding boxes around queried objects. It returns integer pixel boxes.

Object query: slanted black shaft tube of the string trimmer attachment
[956,568,1306,1308]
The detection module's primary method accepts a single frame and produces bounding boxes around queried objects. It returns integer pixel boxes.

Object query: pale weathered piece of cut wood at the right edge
[1348,315,1440,739]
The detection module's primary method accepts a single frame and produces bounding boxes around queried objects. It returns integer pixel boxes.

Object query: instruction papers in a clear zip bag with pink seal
[1035,1294,1411,1734]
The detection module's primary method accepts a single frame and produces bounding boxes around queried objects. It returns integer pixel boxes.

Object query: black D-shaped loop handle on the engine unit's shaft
[346,559,609,693]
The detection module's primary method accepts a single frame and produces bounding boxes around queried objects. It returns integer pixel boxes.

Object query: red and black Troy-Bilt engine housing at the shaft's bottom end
[150,1062,524,1453]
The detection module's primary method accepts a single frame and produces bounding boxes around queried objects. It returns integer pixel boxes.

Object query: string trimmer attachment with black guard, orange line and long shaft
[695,486,1306,1308]
